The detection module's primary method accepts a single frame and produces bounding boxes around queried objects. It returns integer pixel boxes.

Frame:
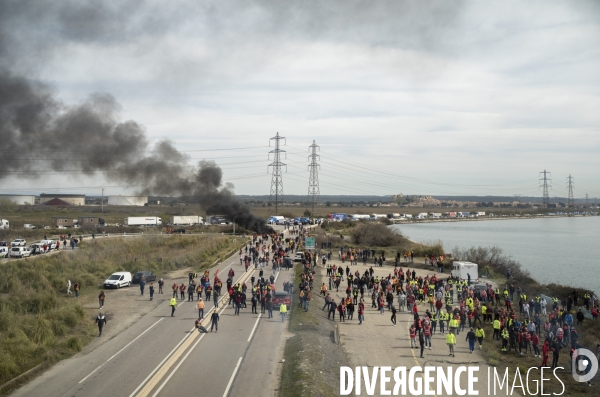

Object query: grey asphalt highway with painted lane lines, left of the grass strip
[12,248,295,397]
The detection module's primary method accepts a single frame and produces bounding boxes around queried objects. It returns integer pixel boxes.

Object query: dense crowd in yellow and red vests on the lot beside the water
[320,254,600,384]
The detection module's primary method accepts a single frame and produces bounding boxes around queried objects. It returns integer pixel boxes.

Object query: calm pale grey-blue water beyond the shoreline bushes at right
[391,216,600,293]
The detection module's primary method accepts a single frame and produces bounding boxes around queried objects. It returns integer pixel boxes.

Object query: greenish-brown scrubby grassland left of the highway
[0,236,244,385]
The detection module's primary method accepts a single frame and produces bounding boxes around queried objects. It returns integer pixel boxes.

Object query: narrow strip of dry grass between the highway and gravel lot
[279,266,346,397]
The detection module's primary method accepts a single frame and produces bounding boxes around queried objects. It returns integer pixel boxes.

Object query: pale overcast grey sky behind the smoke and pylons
[0,0,600,197]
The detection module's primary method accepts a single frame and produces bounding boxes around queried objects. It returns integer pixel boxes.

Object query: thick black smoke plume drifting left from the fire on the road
[0,71,270,232]
